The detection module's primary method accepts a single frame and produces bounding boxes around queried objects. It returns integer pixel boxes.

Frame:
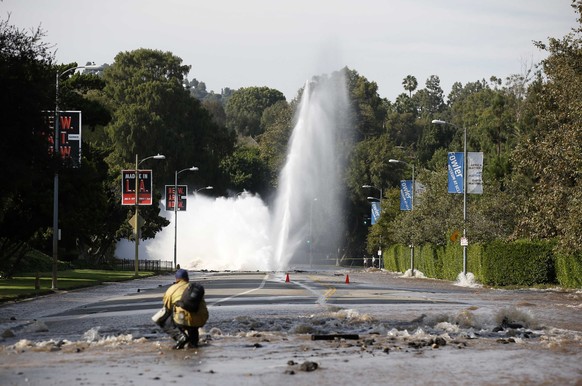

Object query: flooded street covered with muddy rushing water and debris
[0,270,582,385]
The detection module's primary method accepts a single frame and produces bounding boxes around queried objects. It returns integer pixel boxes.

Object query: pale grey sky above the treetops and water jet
[0,0,577,101]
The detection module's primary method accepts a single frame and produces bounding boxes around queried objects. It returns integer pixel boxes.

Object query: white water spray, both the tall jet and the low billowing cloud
[116,72,349,271]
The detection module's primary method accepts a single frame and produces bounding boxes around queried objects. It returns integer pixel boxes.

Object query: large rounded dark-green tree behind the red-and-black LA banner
[104,49,234,238]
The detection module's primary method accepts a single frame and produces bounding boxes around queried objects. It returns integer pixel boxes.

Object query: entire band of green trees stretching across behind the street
[0,0,582,276]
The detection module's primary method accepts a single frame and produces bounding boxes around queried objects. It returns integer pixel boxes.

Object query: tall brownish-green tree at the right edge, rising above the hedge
[515,0,582,253]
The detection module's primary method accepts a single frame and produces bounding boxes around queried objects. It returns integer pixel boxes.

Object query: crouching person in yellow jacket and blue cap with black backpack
[162,269,208,349]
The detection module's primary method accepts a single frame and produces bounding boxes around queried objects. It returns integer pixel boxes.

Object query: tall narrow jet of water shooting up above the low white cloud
[272,72,349,269]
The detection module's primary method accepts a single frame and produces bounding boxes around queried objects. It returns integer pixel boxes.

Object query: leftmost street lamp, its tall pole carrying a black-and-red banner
[52,65,103,290]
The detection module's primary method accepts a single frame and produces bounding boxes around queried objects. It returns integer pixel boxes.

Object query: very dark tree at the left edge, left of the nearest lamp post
[0,15,55,276]
